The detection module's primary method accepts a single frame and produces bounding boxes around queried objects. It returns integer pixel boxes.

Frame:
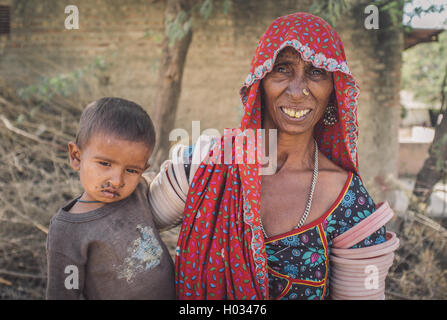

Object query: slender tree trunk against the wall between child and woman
[152,0,193,170]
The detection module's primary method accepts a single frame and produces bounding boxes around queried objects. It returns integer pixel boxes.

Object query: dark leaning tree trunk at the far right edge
[410,67,447,212]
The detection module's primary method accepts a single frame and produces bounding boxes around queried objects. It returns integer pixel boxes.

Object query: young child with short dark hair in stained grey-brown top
[47,98,175,299]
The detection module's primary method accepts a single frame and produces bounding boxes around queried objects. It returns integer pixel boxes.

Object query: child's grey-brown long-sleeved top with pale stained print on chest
[47,178,175,299]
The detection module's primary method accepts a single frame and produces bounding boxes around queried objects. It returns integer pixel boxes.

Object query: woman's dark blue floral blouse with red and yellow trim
[265,173,386,300]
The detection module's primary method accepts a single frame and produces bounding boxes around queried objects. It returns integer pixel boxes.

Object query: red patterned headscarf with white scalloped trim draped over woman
[176,12,359,299]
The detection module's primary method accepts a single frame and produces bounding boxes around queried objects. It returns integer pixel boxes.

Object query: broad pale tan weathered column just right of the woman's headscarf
[336,0,403,206]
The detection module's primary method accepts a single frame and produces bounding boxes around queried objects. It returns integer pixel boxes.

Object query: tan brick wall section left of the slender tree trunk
[0,0,163,105]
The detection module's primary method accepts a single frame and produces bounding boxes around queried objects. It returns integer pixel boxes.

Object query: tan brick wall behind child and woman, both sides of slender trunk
[0,0,318,132]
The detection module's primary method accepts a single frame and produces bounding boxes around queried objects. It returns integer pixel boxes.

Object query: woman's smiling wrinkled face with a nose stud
[261,47,333,134]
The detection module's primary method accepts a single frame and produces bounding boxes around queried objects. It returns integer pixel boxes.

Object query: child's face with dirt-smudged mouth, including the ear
[68,134,152,203]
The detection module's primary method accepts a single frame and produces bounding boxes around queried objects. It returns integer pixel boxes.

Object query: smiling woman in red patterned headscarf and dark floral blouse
[150,13,396,299]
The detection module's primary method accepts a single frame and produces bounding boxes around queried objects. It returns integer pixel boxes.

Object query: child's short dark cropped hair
[76,97,155,149]
